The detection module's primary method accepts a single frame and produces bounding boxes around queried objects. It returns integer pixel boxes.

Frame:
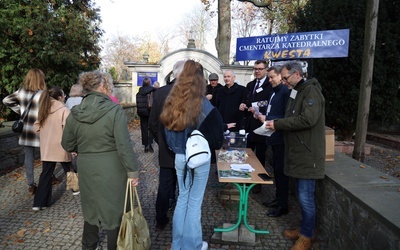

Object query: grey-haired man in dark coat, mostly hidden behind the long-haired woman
[149,61,185,230]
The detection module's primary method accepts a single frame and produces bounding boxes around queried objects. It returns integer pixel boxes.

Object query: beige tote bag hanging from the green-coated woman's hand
[117,179,151,250]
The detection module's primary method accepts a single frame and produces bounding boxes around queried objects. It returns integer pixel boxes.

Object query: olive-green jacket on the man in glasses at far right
[274,78,325,179]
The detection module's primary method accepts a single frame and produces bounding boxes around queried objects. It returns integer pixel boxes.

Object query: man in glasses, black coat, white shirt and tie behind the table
[239,60,272,193]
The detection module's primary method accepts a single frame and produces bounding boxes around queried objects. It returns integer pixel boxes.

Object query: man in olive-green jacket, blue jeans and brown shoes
[266,62,325,249]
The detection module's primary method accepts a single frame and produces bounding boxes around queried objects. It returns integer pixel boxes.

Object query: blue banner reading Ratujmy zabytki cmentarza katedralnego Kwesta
[236,29,350,61]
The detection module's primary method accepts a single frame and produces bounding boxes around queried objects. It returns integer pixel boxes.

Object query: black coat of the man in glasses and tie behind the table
[242,78,272,142]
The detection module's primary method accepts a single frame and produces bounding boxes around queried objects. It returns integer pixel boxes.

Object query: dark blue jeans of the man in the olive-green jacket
[296,179,316,238]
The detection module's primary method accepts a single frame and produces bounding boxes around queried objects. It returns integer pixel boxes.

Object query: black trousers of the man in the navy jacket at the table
[271,144,289,209]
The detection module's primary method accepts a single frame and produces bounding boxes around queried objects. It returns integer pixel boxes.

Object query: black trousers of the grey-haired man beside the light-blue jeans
[156,167,177,224]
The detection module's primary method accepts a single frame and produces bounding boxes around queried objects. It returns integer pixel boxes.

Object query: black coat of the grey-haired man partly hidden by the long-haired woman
[149,80,175,168]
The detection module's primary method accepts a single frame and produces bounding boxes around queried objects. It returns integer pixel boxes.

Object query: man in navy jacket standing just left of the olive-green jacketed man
[259,66,290,217]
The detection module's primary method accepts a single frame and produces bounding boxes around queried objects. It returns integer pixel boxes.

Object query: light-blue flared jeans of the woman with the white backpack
[172,154,210,250]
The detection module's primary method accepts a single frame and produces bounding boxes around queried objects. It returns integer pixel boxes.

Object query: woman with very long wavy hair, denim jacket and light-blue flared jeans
[160,60,223,250]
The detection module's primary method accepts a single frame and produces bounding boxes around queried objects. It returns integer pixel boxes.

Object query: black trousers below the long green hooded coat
[82,221,119,250]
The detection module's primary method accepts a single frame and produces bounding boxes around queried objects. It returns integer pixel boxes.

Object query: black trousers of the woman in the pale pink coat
[33,161,72,207]
